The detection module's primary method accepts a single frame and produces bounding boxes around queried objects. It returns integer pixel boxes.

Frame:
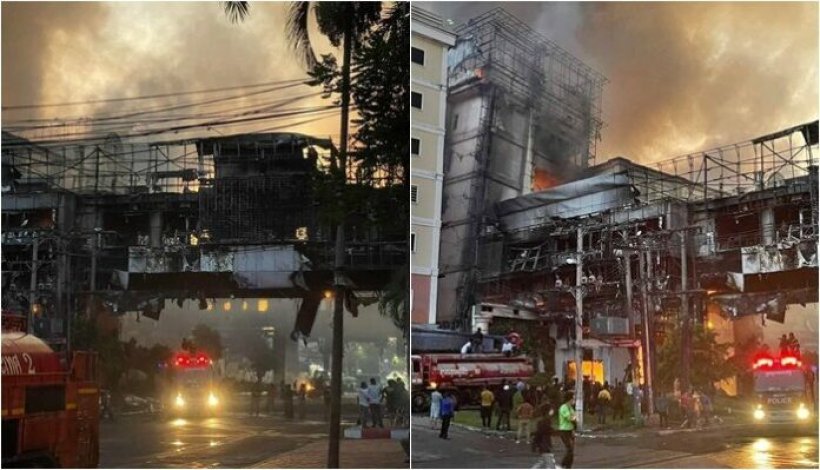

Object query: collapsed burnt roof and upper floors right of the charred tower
[477,121,818,340]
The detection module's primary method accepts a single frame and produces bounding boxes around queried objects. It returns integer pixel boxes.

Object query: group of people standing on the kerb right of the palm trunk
[357,377,410,428]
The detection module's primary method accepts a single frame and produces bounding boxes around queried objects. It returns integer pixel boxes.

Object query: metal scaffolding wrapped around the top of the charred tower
[449,8,606,167]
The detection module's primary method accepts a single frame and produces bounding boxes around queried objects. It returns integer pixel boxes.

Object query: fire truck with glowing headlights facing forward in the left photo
[164,352,223,416]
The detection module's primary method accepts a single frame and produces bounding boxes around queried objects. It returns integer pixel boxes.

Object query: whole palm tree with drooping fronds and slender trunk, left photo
[223,2,381,468]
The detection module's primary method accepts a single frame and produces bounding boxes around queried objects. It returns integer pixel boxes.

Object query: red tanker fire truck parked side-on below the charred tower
[411,353,535,409]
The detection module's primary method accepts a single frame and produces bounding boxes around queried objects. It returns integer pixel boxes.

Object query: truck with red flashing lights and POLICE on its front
[752,352,817,425]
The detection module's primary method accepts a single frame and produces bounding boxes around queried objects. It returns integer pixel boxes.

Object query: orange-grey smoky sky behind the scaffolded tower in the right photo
[414,2,820,162]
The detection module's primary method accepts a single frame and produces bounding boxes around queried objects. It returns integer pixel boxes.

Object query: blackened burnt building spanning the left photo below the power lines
[2,131,407,341]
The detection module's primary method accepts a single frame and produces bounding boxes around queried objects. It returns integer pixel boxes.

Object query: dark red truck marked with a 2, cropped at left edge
[2,312,100,468]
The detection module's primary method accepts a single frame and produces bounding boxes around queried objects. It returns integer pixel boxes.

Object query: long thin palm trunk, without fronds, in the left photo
[327,15,352,468]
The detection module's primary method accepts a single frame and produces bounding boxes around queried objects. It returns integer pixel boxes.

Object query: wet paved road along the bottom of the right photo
[412,423,820,468]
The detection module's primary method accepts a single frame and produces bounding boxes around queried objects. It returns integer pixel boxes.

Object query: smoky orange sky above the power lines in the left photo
[0,1,338,138]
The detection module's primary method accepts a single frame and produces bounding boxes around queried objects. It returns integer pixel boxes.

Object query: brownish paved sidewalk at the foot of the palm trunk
[251,439,410,468]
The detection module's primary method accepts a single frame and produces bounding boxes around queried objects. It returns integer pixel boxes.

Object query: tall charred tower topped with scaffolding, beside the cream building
[437,8,606,328]
